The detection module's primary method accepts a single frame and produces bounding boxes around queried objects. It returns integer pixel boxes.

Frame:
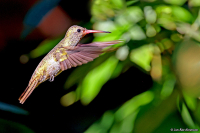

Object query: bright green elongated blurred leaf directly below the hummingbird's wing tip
[81,56,118,105]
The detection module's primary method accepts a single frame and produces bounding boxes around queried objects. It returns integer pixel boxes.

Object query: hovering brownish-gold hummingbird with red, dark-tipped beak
[19,25,120,104]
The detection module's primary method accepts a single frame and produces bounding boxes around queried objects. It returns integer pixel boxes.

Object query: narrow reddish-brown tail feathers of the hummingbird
[19,78,38,104]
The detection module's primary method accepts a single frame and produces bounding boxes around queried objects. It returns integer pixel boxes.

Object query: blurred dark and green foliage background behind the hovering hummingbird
[0,0,200,133]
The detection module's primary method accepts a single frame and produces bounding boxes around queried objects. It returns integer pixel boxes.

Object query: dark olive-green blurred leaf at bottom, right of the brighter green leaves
[133,91,178,133]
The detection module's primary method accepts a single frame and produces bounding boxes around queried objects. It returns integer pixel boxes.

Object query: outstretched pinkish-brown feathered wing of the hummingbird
[56,41,121,71]
